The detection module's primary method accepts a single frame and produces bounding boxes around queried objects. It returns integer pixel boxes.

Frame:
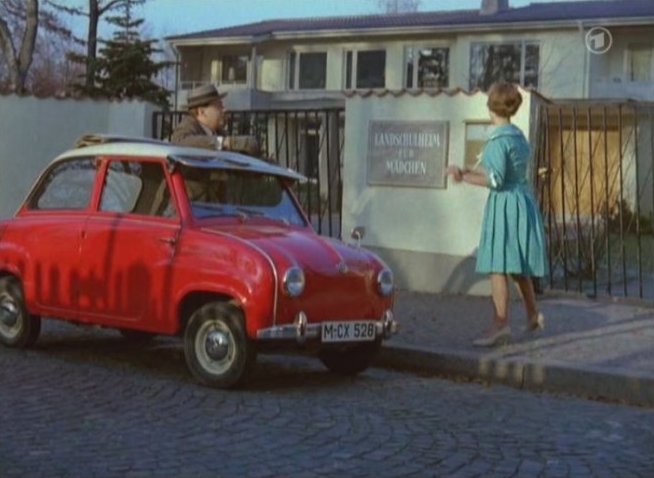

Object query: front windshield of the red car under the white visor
[181,166,306,226]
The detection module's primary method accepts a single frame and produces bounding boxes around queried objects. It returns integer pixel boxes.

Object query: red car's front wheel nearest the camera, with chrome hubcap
[184,302,256,388]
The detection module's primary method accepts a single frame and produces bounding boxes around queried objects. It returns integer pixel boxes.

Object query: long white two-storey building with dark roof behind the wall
[168,0,654,110]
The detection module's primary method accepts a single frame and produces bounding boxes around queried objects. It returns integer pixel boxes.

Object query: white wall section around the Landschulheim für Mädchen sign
[342,91,531,294]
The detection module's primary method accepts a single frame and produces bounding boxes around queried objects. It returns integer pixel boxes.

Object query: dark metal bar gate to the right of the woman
[535,102,654,300]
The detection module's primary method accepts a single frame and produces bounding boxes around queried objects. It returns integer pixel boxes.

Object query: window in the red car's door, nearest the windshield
[100,161,175,217]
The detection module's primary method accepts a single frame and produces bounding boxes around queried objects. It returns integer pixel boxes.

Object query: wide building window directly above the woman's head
[470,41,540,91]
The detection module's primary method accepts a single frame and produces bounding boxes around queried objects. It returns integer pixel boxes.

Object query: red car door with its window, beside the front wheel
[79,159,181,331]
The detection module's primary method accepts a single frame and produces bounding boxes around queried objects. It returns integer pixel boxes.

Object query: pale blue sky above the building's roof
[70,0,584,38]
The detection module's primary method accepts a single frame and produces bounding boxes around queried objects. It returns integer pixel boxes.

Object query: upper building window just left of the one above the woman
[404,47,450,88]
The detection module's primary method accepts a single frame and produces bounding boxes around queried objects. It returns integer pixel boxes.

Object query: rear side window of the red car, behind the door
[29,158,96,209]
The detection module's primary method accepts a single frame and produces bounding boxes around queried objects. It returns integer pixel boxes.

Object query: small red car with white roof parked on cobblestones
[0,136,397,388]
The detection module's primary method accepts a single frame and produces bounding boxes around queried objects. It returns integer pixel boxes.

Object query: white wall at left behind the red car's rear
[0,95,155,218]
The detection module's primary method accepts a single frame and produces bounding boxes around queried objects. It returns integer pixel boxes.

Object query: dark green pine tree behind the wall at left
[77,0,170,108]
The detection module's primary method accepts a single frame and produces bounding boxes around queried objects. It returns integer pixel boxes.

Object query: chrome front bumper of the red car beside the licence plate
[257,309,399,344]
